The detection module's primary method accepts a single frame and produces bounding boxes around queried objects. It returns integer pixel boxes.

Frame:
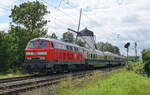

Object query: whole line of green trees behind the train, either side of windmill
[0,1,120,73]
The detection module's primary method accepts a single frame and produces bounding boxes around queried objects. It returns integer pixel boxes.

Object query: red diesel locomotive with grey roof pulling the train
[24,38,87,73]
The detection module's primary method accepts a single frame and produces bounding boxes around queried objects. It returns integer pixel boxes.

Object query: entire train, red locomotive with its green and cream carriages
[24,38,125,74]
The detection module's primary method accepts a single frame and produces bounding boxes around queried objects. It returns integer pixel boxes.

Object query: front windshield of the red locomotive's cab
[27,41,47,48]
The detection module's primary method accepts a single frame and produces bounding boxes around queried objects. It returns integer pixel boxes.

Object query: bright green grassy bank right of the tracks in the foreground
[57,69,150,95]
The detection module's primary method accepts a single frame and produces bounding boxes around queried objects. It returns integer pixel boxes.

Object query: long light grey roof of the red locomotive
[31,38,83,48]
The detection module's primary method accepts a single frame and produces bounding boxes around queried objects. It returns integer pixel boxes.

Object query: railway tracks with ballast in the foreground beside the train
[0,66,120,95]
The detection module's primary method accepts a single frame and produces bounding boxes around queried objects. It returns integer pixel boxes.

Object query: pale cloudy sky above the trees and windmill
[0,0,150,55]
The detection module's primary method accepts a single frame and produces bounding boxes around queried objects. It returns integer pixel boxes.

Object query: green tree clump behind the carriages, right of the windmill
[97,42,120,55]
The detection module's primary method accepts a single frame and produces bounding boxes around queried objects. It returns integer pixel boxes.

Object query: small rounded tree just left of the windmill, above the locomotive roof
[62,32,74,43]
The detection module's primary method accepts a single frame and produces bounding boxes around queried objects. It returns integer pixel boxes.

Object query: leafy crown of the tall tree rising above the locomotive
[9,1,49,39]
